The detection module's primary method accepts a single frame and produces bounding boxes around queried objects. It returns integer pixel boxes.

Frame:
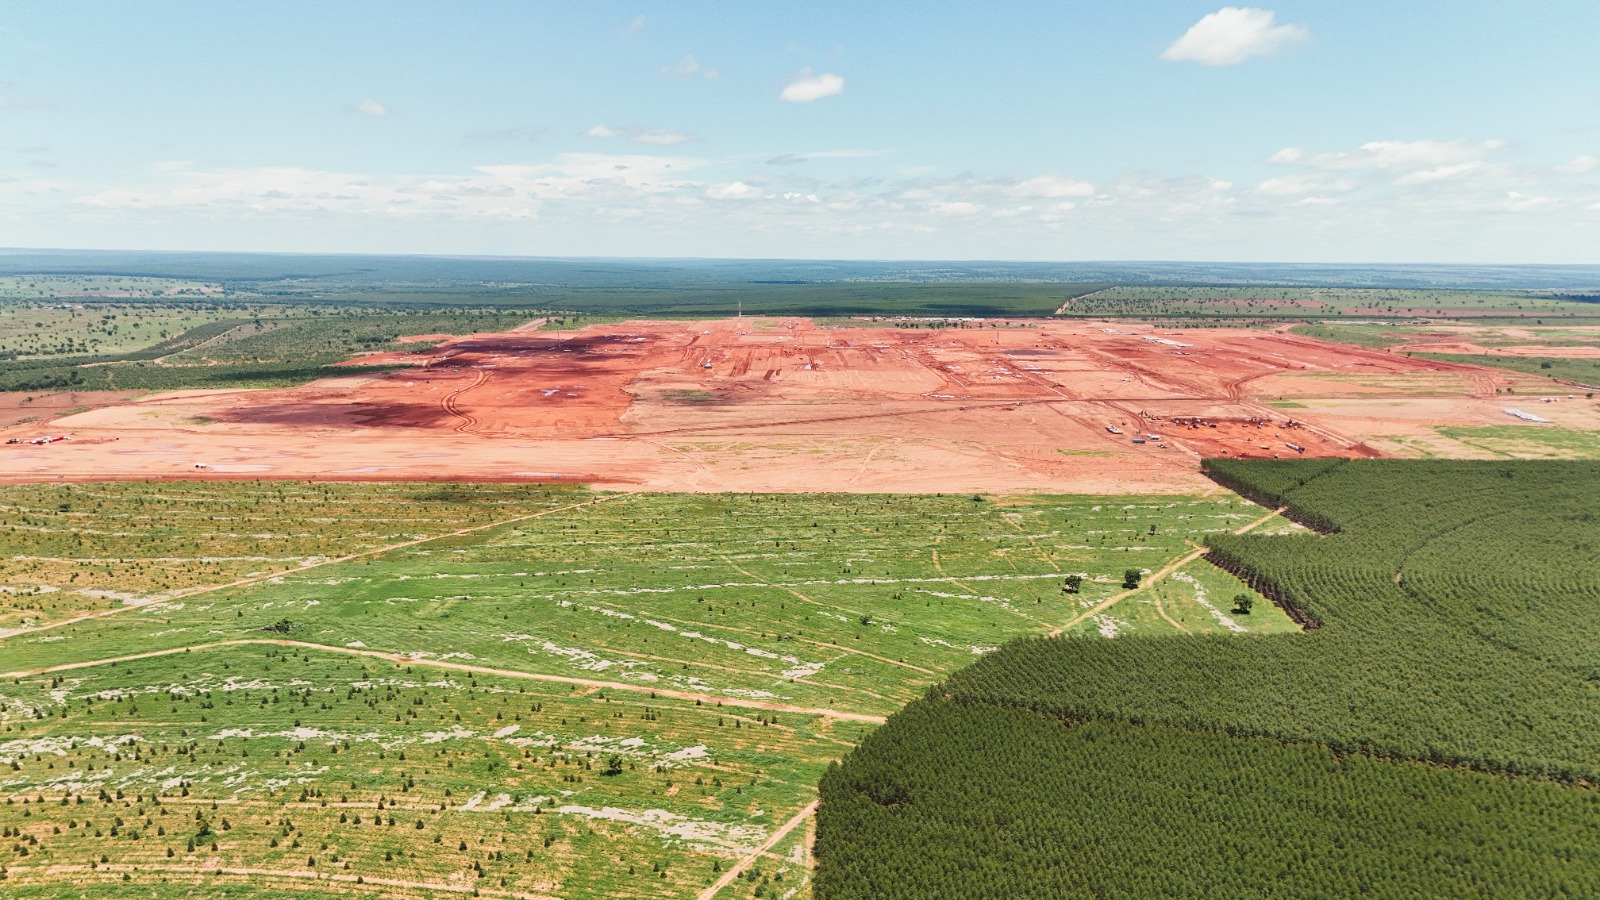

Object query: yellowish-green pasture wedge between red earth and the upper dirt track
[0,482,579,636]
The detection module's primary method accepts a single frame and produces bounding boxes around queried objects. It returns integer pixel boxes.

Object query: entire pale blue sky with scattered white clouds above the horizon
[0,0,1600,263]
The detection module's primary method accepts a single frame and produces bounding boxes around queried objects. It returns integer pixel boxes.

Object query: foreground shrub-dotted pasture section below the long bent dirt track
[0,647,866,897]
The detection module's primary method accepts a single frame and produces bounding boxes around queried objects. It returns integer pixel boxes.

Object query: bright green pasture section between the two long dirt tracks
[8,484,1292,714]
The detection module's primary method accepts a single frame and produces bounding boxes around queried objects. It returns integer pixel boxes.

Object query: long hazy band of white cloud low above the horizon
[31,127,1600,261]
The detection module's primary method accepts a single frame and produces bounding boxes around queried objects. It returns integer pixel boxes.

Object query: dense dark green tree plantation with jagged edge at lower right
[818,460,1600,900]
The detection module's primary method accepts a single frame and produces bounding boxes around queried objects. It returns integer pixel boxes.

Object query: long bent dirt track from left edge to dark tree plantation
[0,637,886,725]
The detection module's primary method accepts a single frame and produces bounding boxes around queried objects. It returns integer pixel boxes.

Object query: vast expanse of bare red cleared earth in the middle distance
[0,319,1600,493]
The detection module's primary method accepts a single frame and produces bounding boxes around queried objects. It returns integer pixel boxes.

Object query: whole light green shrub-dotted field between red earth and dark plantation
[0,482,1294,897]
